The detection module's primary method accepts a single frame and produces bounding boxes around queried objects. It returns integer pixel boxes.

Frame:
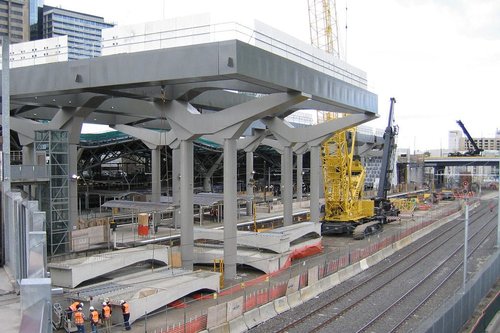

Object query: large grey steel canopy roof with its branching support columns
[1,40,377,279]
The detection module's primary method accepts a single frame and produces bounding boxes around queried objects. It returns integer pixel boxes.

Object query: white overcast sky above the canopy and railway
[45,0,500,151]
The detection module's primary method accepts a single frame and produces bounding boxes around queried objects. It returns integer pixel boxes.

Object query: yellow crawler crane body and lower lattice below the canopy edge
[321,114,379,238]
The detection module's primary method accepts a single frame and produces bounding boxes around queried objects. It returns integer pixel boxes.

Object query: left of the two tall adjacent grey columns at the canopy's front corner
[180,140,194,270]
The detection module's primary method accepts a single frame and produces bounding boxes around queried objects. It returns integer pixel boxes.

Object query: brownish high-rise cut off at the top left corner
[0,0,29,43]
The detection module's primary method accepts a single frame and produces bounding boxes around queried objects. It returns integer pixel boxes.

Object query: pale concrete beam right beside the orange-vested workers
[71,268,220,324]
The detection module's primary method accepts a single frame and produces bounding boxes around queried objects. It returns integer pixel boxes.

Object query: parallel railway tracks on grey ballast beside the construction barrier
[251,200,495,333]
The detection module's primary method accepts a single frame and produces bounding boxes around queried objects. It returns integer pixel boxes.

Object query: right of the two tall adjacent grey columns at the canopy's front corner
[224,139,238,279]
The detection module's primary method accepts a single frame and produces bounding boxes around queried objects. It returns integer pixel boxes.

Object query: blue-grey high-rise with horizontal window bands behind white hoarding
[43,6,114,60]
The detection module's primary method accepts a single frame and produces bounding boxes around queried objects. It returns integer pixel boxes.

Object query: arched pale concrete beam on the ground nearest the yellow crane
[194,222,321,253]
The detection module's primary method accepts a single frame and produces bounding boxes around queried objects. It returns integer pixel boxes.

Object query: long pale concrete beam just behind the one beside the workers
[48,244,169,288]
